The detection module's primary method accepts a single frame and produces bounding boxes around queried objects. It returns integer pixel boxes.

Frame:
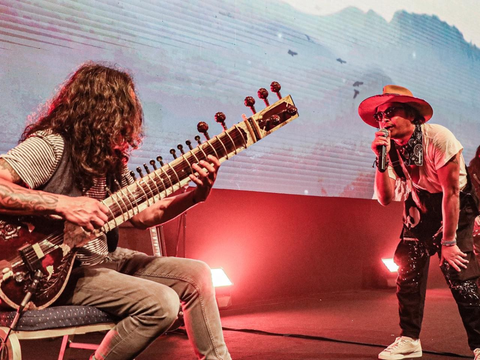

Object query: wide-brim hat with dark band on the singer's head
[358,85,433,128]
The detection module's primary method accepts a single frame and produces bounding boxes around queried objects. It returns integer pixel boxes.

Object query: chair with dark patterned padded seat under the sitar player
[0,305,116,360]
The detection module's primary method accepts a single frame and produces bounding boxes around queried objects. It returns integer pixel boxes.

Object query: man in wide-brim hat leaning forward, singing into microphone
[358,85,480,360]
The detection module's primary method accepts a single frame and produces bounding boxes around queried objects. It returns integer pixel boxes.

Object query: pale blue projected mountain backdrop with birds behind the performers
[0,0,480,198]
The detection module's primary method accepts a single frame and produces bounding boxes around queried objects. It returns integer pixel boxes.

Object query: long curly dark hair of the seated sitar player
[20,62,143,190]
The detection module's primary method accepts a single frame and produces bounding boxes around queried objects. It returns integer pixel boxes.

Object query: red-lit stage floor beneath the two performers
[22,288,473,360]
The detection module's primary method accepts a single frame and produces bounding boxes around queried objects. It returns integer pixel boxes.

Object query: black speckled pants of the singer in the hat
[395,241,480,350]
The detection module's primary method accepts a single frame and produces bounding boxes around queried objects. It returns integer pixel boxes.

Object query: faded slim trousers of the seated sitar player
[58,248,231,360]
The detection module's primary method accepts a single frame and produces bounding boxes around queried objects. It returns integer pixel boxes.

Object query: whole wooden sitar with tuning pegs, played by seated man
[0,82,298,309]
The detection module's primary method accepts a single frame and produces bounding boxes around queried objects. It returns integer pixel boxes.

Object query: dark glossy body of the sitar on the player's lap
[0,216,75,309]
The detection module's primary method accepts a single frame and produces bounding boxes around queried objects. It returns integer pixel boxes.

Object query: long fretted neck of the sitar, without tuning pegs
[102,96,298,232]
